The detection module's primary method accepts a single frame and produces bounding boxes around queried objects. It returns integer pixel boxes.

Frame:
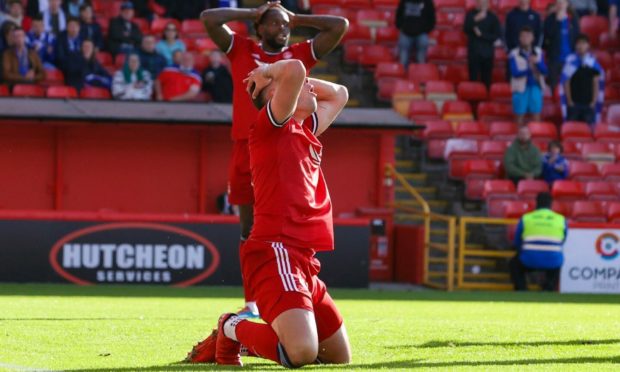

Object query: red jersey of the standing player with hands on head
[226,34,317,140]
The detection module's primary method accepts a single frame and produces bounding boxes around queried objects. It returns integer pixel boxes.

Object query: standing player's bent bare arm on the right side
[289,14,349,58]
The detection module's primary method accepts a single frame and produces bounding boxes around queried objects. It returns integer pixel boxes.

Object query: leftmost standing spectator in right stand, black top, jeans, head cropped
[396,0,436,69]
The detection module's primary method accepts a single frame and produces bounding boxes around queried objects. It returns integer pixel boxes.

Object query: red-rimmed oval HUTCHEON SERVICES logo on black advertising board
[49,223,220,287]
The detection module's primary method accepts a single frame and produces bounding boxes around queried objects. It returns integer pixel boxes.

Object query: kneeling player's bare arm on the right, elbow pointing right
[308,78,349,136]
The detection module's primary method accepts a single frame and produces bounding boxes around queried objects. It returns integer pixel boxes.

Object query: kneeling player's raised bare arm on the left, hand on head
[247,59,306,123]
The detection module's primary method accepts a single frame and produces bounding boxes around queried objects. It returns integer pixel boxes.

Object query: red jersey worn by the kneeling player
[249,104,334,251]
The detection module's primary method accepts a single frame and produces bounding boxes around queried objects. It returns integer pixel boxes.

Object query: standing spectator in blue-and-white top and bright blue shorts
[508,26,547,126]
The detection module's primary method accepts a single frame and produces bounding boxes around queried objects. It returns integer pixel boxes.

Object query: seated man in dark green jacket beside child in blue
[504,126,542,185]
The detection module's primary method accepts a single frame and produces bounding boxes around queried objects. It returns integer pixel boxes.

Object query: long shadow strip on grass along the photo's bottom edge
[70,356,620,372]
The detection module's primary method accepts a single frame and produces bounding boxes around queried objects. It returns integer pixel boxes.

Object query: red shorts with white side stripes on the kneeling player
[241,239,343,341]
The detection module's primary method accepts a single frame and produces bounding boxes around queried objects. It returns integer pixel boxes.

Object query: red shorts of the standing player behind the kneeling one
[228,140,254,205]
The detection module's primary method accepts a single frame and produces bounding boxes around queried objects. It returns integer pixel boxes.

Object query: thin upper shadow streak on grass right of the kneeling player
[385,339,620,349]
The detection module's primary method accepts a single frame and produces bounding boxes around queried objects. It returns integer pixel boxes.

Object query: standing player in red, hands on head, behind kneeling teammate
[201,1,348,316]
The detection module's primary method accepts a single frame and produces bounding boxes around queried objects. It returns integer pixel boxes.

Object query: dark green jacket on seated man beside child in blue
[504,139,542,178]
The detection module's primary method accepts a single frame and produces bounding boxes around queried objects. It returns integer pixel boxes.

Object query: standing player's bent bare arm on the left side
[200,3,273,52]
